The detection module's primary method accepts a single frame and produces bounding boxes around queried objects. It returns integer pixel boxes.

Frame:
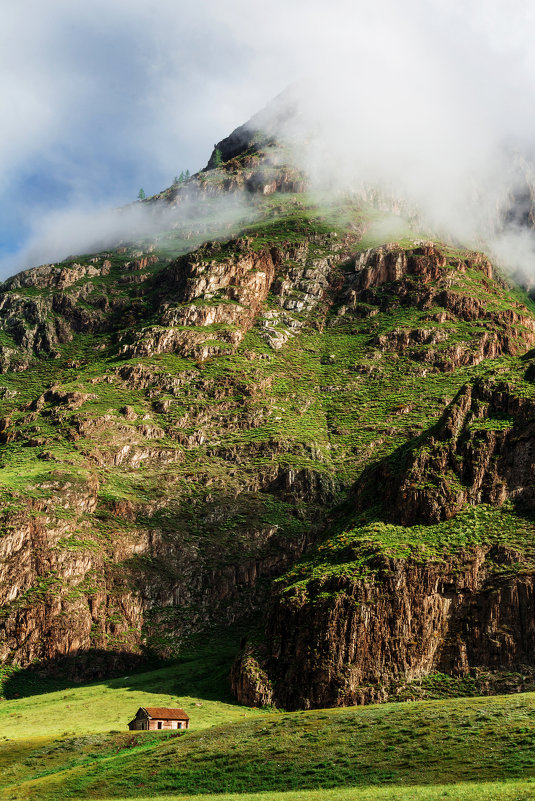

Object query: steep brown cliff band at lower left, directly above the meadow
[0,483,310,679]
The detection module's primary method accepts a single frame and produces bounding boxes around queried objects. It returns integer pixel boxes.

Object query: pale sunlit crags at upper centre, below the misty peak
[119,235,347,360]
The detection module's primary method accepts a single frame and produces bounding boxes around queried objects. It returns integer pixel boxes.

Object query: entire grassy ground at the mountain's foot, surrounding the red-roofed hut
[0,664,535,801]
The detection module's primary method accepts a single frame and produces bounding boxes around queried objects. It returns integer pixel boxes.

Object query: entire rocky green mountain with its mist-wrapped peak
[0,101,535,709]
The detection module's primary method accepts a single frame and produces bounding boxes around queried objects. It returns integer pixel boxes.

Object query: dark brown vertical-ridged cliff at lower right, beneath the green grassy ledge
[232,543,535,709]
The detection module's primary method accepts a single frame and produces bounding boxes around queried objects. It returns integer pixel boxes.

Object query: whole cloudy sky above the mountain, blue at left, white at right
[0,0,535,277]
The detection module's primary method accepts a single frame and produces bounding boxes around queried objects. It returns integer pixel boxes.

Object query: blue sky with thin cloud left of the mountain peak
[0,0,298,275]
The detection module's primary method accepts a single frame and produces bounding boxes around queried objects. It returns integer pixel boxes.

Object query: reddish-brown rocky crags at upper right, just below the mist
[337,242,535,372]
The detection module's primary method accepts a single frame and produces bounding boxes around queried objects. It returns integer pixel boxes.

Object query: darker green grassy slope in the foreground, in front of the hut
[5,693,535,801]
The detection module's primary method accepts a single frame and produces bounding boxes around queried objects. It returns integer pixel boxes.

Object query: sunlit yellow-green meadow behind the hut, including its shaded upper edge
[0,637,259,740]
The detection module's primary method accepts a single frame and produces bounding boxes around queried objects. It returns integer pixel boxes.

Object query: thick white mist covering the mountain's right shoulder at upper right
[266,2,535,274]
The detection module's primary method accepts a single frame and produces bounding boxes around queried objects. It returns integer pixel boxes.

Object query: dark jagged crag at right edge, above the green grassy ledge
[368,368,535,525]
